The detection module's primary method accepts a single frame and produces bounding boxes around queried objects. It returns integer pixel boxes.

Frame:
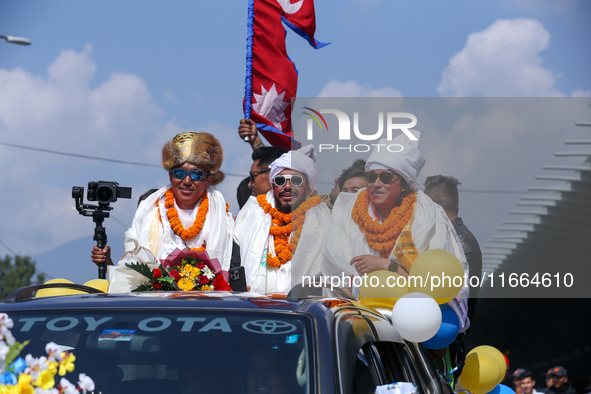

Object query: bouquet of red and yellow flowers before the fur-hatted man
[126,249,232,290]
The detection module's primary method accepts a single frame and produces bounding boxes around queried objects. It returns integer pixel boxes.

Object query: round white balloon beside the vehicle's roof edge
[392,292,441,342]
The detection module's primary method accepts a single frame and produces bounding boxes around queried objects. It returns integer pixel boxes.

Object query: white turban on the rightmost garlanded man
[365,130,425,190]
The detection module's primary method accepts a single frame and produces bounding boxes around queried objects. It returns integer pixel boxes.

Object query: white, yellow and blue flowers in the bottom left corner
[0,313,94,394]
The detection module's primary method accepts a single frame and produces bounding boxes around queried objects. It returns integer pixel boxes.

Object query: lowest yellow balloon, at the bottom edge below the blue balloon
[460,352,502,394]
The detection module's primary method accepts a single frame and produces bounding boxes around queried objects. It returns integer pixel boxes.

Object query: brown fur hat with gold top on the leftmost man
[162,131,226,185]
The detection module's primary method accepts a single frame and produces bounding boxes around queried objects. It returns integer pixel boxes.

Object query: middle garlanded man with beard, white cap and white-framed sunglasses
[232,145,330,293]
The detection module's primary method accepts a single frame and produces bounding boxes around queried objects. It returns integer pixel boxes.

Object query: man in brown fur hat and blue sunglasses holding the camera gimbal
[92,131,233,270]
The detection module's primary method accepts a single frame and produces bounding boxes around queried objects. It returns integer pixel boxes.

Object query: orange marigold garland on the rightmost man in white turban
[351,190,417,259]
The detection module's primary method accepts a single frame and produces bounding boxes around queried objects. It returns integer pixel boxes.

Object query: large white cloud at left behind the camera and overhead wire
[0,45,180,254]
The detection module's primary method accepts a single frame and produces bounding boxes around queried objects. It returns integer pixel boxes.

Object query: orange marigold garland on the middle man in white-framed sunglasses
[257,194,320,268]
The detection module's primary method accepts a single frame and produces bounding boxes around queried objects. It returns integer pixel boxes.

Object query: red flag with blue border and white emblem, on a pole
[244,0,328,149]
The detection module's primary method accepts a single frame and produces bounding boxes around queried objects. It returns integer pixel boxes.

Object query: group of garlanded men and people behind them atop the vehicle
[91,119,482,327]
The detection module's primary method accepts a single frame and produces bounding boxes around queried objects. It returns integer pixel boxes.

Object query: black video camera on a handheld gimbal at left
[72,181,131,279]
